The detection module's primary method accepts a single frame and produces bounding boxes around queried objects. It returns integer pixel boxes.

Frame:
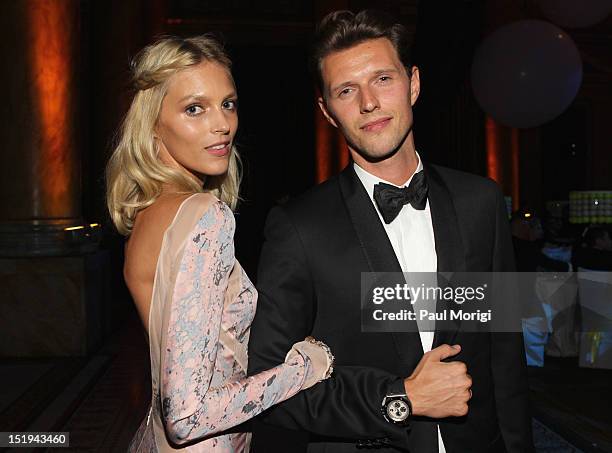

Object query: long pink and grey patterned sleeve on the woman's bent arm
[160,201,318,444]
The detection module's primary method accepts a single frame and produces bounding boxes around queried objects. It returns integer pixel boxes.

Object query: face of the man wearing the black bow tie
[319,38,419,162]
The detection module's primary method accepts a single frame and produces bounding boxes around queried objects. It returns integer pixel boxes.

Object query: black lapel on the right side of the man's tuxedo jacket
[424,165,466,348]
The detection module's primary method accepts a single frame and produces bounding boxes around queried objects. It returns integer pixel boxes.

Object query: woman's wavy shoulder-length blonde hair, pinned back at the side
[106,35,241,236]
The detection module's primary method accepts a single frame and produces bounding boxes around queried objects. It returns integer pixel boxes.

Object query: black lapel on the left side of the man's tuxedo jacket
[339,164,423,361]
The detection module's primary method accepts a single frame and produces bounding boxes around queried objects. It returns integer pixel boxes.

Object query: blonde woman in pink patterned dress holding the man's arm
[107,36,333,452]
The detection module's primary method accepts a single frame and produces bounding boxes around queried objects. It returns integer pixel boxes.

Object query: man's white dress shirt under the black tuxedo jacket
[353,153,446,453]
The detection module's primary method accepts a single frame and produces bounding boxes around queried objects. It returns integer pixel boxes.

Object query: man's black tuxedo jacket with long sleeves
[249,165,533,453]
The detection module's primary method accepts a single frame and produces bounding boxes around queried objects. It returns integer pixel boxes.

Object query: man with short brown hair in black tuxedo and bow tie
[249,11,533,453]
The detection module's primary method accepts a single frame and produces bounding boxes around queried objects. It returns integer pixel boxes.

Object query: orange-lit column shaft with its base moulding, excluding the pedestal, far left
[0,0,95,256]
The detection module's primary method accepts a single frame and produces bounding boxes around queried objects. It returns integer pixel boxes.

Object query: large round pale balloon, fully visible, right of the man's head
[471,20,582,128]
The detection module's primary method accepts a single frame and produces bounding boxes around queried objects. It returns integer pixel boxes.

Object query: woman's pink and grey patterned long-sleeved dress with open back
[129,194,320,452]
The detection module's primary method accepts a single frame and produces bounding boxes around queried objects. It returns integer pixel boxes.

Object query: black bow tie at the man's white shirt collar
[374,171,427,224]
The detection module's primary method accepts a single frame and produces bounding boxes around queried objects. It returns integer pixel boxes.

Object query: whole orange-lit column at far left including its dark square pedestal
[0,0,109,357]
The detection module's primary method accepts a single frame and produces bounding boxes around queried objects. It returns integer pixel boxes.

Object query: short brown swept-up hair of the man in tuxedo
[310,10,412,92]
